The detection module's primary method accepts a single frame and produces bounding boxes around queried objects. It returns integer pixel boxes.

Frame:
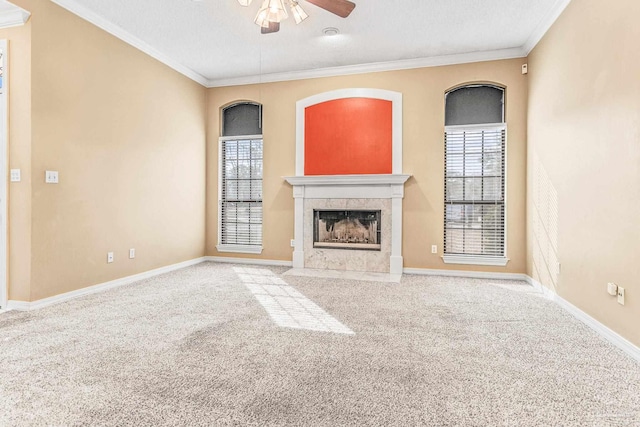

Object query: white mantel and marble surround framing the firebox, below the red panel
[284,174,410,275]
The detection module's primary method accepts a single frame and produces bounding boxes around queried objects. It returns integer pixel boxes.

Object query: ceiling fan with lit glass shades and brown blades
[238,0,356,34]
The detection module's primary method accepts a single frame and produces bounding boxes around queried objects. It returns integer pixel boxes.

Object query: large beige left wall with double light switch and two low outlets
[9,0,206,300]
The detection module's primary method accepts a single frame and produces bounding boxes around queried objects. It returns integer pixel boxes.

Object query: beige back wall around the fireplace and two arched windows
[206,59,527,273]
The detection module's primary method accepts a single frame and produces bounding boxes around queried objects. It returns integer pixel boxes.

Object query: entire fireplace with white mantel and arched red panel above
[284,88,409,278]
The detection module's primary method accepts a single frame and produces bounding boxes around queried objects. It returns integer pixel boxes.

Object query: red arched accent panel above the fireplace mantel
[304,98,393,175]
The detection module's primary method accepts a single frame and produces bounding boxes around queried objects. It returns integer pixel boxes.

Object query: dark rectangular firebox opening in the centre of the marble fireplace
[313,209,382,251]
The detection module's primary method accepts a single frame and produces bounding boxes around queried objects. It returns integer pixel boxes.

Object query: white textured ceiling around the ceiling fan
[40,0,570,86]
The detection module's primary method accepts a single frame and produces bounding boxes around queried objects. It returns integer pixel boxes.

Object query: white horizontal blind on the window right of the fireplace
[444,124,506,257]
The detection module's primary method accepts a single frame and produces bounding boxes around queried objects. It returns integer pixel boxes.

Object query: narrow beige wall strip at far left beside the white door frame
[0,22,31,301]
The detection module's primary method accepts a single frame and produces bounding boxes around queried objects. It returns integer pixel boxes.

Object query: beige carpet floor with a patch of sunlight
[0,263,640,426]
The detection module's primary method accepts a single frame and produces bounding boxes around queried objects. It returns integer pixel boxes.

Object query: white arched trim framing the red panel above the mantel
[296,88,402,176]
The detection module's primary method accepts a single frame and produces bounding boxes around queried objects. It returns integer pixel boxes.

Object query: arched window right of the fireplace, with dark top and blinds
[444,85,507,265]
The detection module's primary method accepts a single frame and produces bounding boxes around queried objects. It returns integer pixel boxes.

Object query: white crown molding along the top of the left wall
[51,0,208,86]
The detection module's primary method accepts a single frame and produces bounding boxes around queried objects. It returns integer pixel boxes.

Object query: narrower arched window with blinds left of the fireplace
[217,102,262,253]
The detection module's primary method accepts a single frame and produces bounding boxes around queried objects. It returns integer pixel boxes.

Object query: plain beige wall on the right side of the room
[527,0,640,345]
